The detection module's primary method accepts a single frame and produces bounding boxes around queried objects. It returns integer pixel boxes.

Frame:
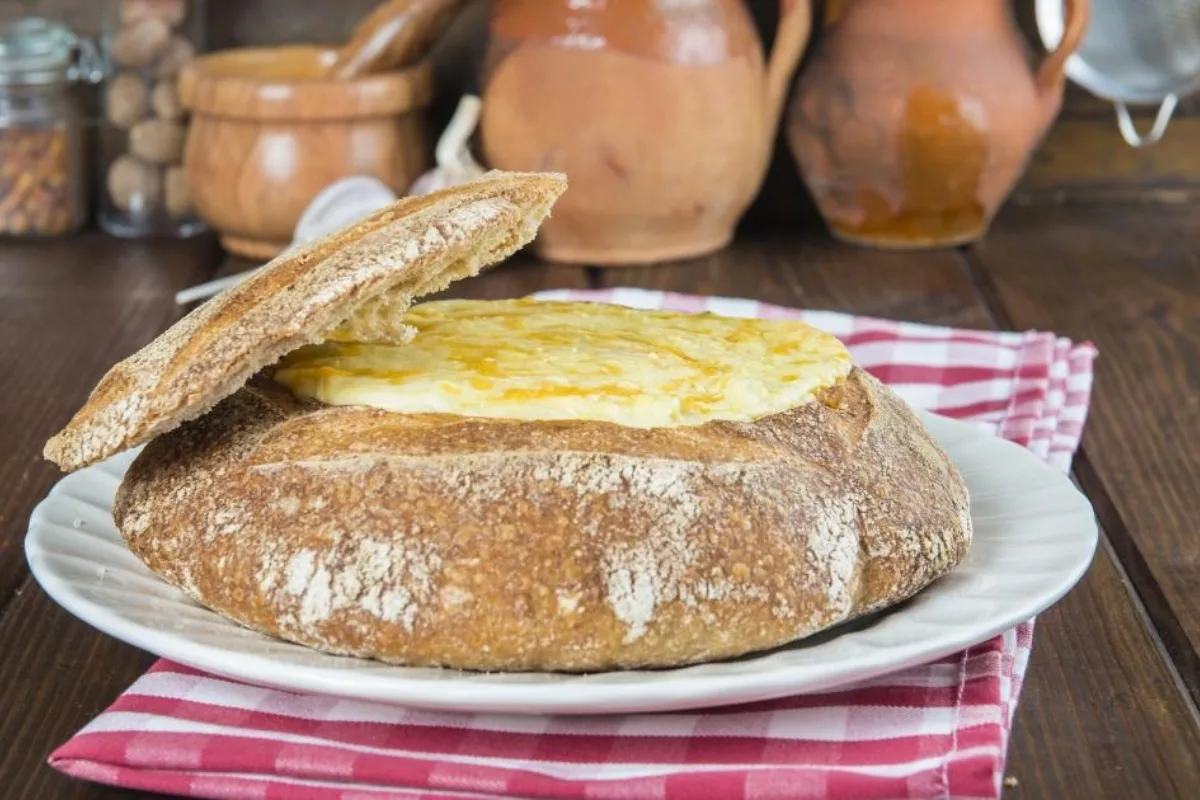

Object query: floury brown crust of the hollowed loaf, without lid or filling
[114,369,971,672]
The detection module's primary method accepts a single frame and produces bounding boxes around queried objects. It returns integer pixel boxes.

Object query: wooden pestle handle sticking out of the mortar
[329,0,464,80]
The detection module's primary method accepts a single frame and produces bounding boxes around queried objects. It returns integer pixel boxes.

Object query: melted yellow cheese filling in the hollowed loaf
[275,300,851,427]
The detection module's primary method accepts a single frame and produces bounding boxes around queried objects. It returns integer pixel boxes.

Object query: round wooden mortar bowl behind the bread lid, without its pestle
[180,47,432,259]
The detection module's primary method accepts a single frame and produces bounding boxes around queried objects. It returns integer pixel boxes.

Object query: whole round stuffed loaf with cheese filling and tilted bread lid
[46,173,971,672]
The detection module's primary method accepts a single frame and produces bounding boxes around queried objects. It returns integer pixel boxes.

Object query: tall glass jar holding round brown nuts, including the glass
[98,0,205,237]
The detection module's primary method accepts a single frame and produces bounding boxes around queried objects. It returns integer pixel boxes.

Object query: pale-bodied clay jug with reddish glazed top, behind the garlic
[481,0,811,265]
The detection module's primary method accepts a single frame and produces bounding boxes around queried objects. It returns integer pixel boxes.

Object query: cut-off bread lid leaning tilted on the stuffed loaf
[44,172,566,470]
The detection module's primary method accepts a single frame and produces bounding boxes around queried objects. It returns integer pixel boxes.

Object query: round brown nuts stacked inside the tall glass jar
[106,0,196,219]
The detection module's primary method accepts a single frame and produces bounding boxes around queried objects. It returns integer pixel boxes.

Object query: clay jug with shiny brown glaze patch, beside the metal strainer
[787,0,1088,248]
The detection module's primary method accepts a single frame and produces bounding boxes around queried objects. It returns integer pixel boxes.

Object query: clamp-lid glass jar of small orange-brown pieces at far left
[0,17,100,236]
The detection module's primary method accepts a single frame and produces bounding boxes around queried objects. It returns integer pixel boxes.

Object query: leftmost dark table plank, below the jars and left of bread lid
[0,234,217,613]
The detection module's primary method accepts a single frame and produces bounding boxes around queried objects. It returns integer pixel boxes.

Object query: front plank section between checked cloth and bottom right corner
[1008,527,1200,800]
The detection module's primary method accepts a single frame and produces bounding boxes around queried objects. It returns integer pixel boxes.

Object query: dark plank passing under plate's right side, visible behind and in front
[601,236,1200,800]
